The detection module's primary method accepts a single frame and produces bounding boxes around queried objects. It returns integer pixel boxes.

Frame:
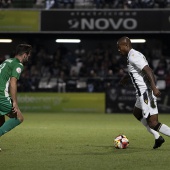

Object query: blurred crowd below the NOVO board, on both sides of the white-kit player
[1,40,170,92]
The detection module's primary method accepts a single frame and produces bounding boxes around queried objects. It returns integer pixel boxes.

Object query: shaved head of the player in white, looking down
[117,37,132,55]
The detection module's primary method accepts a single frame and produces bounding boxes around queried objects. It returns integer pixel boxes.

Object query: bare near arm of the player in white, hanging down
[142,65,161,97]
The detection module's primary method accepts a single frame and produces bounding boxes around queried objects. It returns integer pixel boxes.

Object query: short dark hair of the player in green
[15,44,32,55]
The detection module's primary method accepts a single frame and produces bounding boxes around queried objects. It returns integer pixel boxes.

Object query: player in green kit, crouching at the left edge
[0,44,32,150]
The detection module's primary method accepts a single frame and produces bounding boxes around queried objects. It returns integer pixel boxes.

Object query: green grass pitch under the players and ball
[0,113,170,170]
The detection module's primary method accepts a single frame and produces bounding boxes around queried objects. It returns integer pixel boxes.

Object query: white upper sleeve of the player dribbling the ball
[129,53,148,70]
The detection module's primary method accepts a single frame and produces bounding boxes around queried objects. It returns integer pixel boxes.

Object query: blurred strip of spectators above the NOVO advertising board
[0,0,169,9]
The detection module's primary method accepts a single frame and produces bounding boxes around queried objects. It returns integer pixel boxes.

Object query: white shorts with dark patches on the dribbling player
[135,90,158,118]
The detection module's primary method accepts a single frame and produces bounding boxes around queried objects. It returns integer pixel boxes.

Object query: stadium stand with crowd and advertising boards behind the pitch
[0,0,170,113]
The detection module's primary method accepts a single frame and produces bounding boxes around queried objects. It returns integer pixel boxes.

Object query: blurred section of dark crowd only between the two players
[17,44,124,92]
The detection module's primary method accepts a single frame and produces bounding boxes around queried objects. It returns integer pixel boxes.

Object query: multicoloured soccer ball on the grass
[114,135,129,149]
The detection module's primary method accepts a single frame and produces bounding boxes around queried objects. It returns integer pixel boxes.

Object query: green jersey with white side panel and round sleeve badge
[0,58,24,97]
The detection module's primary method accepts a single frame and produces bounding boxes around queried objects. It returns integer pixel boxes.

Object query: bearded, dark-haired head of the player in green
[15,44,32,64]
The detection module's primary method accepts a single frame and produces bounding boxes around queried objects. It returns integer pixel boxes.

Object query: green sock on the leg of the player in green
[0,118,21,136]
